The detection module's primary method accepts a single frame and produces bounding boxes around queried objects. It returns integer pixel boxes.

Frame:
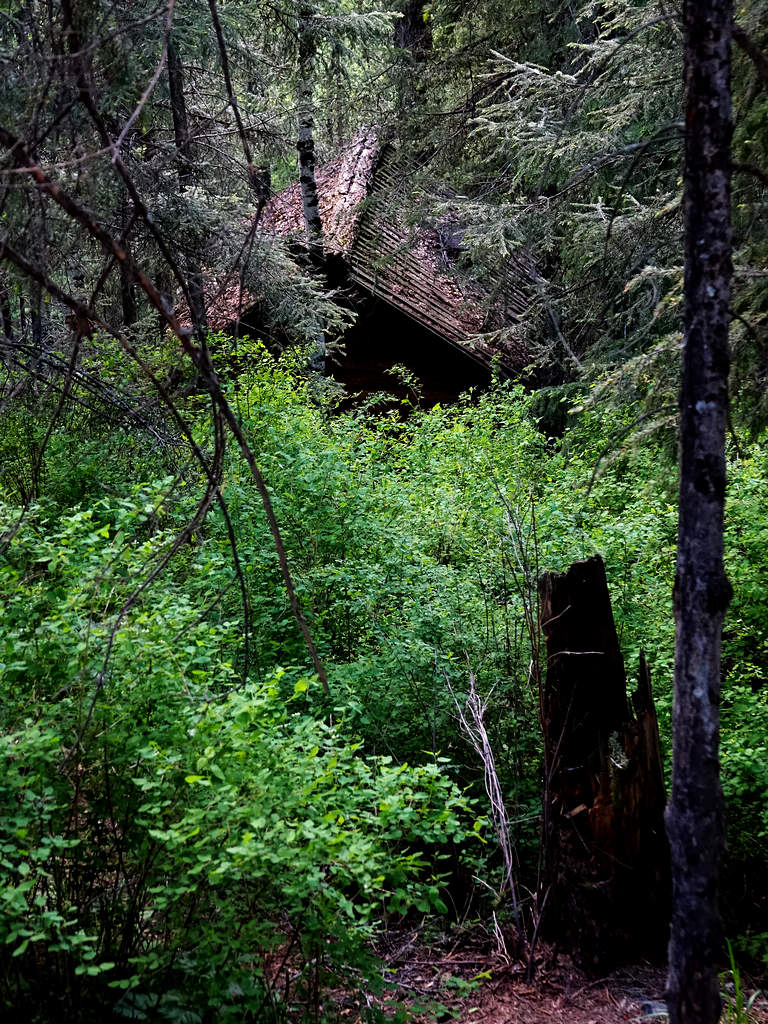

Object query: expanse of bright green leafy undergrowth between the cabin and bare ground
[0,348,768,1022]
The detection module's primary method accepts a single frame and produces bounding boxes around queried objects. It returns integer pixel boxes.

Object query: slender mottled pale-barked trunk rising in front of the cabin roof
[296,3,326,374]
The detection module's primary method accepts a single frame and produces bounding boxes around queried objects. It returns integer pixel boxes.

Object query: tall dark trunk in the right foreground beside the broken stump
[667,0,733,1024]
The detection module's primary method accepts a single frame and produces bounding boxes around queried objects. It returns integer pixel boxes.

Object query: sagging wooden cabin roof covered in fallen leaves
[195,128,531,369]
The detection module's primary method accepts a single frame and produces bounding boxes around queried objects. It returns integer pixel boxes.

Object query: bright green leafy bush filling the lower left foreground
[0,480,473,1020]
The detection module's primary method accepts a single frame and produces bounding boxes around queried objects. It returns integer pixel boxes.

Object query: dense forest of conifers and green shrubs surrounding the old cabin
[0,0,768,1022]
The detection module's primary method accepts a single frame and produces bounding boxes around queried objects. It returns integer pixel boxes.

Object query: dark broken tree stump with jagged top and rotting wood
[539,555,669,972]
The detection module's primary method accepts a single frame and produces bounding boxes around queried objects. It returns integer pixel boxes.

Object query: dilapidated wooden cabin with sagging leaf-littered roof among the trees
[201,129,532,401]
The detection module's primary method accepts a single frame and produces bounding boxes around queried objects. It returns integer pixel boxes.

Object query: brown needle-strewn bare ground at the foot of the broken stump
[366,933,768,1024]
